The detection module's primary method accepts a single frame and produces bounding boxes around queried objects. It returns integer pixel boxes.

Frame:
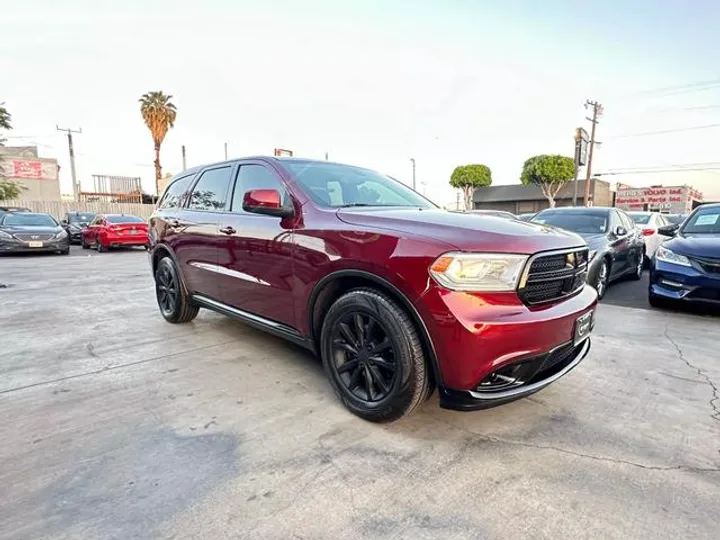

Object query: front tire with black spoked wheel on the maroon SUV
[320,289,432,422]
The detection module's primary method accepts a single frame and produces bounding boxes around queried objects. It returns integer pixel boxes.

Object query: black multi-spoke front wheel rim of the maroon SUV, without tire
[332,313,397,402]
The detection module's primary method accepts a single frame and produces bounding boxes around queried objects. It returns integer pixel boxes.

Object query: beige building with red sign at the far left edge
[0,146,61,201]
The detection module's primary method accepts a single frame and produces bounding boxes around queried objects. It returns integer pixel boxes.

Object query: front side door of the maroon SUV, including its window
[218,163,295,328]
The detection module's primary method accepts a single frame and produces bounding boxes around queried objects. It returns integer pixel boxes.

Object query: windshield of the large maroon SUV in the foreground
[282,160,435,208]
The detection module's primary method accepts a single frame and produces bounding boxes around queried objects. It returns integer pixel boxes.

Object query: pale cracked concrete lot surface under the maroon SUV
[0,247,720,540]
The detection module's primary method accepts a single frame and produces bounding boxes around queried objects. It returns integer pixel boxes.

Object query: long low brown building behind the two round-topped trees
[473,179,614,214]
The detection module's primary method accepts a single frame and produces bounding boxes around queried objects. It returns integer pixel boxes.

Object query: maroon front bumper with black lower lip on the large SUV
[418,284,597,400]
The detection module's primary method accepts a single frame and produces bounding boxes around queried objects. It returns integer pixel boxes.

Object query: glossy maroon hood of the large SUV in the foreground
[337,207,585,254]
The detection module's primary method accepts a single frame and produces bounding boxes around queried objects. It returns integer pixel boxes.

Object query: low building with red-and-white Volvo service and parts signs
[615,184,703,214]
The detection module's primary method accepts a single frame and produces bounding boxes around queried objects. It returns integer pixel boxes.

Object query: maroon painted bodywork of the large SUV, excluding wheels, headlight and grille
[150,158,597,390]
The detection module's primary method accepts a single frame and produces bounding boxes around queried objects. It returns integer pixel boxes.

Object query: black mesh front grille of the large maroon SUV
[518,249,588,304]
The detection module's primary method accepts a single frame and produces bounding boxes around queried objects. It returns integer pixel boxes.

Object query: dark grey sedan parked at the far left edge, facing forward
[0,211,70,255]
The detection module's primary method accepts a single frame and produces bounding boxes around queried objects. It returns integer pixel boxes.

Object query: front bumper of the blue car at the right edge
[648,257,720,304]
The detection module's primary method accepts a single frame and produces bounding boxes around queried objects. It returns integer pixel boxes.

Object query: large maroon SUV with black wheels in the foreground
[149,157,597,421]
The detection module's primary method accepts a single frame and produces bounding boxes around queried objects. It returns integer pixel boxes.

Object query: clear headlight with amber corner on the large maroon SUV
[430,252,528,292]
